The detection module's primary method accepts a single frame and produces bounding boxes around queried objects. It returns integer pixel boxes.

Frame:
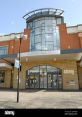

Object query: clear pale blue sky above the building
[0,0,82,35]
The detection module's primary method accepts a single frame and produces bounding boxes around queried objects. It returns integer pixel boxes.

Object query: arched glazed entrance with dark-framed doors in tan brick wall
[26,65,62,90]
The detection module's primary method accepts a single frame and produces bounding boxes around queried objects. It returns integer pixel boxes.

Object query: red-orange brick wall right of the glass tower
[59,24,81,50]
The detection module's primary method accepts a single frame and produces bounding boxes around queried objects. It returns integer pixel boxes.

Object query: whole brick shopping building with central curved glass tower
[0,8,82,90]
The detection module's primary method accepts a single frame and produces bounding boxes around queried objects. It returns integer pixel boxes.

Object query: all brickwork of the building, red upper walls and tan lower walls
[0,24,82,90]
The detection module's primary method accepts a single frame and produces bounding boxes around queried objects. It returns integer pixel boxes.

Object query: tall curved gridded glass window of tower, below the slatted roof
[30,17,61,51]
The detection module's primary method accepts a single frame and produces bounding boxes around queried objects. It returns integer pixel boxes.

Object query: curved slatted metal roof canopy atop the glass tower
[23,8,64,22]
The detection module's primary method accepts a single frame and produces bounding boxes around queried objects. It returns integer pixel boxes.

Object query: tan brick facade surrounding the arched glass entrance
[13,61,79,90]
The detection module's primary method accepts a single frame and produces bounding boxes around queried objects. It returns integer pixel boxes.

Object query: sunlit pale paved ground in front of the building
[0,90,82,109]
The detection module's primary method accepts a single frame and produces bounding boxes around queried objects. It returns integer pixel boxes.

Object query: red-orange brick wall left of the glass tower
[0,29,30,54]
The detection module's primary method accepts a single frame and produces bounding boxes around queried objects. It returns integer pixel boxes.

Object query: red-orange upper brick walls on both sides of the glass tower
[0,24,82,54]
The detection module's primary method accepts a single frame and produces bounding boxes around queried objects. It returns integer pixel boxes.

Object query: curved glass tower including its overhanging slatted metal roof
[24,8,64,51]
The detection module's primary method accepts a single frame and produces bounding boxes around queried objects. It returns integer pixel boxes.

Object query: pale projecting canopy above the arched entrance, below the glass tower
[17,51,82,62]
